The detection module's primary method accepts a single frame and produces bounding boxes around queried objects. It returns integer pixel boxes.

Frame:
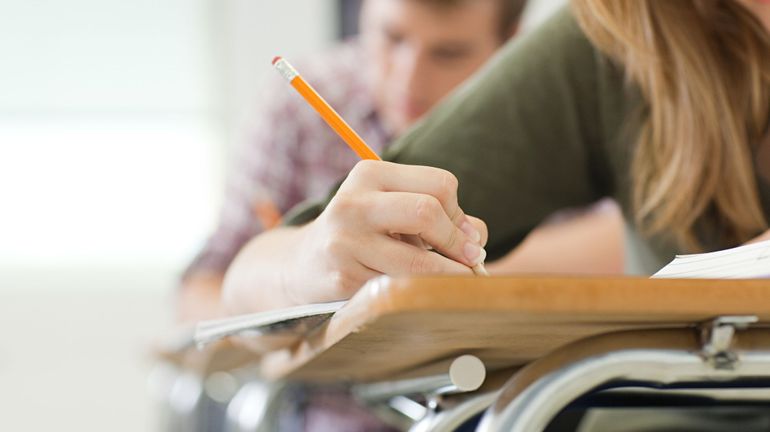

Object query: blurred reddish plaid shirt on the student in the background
[185,40,390,275]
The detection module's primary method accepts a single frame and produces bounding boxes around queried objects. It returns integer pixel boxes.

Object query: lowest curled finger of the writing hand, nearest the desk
[358,235,472,276]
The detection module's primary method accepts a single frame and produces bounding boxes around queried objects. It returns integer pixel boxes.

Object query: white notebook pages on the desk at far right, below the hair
[652,240,770,279]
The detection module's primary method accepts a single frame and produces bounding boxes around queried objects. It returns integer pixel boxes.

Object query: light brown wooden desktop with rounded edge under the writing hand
[262,276,770,381]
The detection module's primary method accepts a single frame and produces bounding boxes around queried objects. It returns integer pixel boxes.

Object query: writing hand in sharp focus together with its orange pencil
[273,57,487,278]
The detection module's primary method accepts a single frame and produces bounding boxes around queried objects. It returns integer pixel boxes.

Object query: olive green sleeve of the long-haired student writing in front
[287,10,606,258]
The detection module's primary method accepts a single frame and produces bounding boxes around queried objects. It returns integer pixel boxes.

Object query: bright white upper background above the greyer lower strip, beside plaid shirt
[0,0,333,265]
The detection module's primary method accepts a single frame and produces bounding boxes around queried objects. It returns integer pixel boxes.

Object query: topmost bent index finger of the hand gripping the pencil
[348,161,465,226]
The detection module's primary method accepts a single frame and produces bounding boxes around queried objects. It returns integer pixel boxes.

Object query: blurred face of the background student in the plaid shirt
[361,0,502,134]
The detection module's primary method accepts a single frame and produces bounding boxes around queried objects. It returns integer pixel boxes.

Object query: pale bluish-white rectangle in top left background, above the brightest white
[0,0,212,115]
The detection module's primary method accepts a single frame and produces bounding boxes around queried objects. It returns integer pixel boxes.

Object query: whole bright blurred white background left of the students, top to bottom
[0,0,564,431]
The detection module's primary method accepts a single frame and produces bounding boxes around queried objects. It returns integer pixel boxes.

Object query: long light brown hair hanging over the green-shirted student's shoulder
[572,0,770,250]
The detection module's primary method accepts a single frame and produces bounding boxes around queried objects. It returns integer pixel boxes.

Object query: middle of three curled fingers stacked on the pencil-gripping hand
[367,192,486,267]
